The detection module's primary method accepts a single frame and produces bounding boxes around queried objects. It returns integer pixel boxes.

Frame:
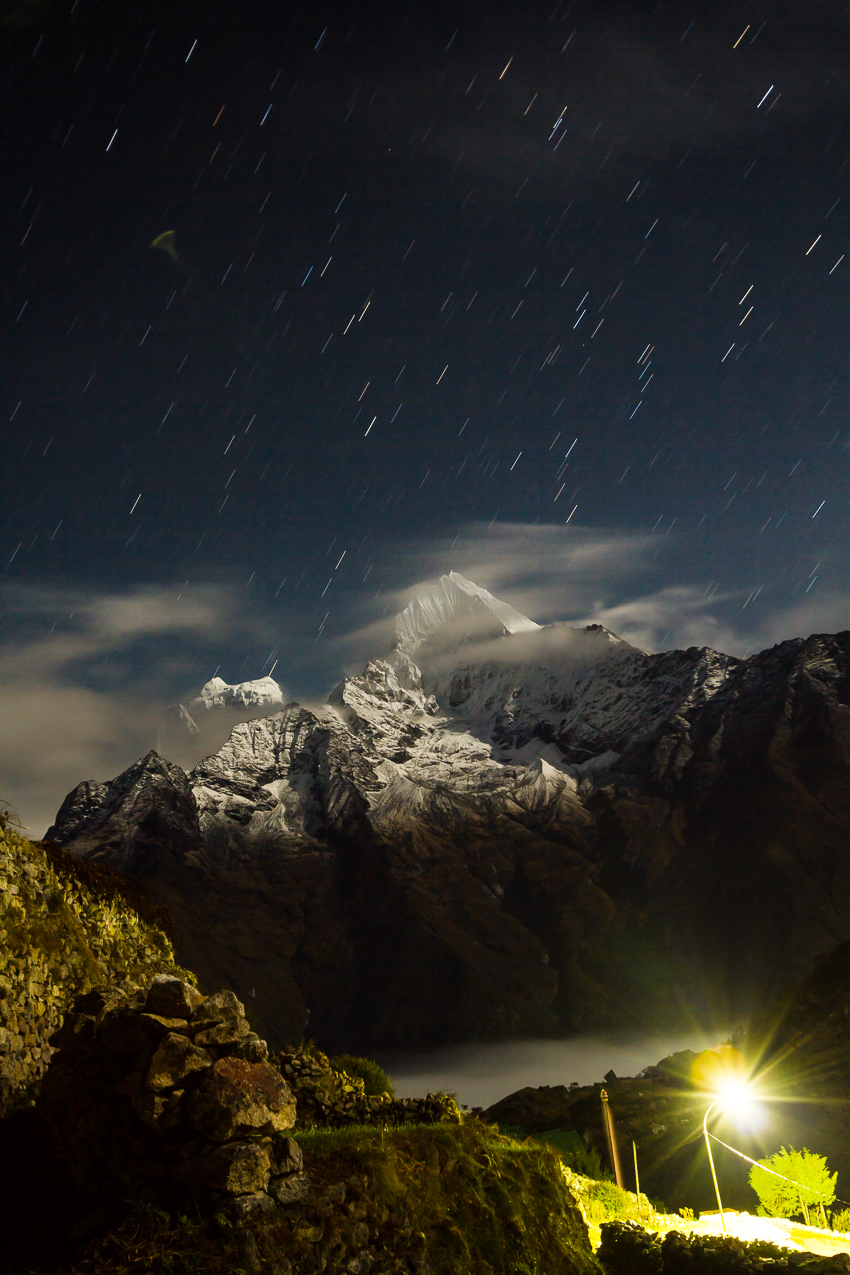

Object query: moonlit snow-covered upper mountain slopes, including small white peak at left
[178,572,739,857]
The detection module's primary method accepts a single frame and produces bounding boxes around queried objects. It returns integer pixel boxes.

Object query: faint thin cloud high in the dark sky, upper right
[384,21,841,198]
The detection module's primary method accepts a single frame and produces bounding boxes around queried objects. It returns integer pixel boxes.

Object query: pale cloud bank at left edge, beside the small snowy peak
[0,587,279,835]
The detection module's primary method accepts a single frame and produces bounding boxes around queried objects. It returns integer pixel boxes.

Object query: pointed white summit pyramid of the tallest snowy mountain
[395,571,540,658]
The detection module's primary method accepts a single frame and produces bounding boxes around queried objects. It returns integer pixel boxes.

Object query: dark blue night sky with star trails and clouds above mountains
[0,0,850,826]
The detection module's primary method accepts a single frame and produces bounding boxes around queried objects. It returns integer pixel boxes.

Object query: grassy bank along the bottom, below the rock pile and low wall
[10,1119,601,1275]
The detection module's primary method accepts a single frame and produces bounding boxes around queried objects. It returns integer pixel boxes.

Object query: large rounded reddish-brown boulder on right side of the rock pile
[190,1058,296,1142]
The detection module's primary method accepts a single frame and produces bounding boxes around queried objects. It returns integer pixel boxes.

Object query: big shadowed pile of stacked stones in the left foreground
[38,974,310,1220]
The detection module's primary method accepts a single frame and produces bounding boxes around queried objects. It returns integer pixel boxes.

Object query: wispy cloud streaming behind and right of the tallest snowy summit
[334,523,850,671]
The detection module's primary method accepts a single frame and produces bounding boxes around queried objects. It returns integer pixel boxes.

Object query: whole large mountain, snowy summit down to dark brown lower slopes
[48,572,850,1049]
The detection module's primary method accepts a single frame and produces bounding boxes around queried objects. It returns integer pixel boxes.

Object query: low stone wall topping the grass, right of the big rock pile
[275,1049,461,1128]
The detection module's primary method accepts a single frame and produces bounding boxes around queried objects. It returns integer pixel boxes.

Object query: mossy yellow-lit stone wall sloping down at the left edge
[0,827,194,1116]
